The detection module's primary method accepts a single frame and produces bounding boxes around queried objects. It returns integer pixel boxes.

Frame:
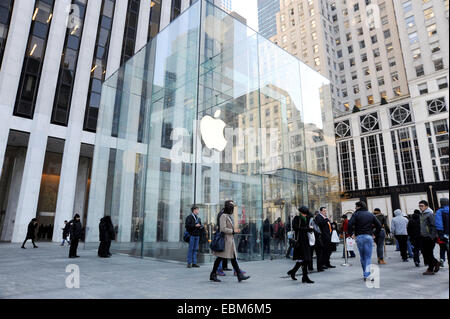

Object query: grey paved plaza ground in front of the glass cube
[0,243,449,299]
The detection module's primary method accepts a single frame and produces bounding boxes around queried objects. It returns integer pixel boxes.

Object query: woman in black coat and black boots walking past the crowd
[288,206,314,284]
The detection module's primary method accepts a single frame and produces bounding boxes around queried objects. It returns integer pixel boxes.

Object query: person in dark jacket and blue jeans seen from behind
[348,201,381,281]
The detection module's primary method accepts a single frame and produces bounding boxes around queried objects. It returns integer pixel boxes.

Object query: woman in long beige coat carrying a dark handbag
[209,200,250,282]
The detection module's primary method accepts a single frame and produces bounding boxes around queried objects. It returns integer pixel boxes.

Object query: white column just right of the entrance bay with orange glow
[53,1,101,241]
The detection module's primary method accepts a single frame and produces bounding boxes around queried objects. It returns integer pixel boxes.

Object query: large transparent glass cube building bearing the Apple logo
[86,1,338,262]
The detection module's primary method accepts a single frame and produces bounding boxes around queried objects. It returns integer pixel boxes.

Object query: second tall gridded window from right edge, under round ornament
[391,126,424,185]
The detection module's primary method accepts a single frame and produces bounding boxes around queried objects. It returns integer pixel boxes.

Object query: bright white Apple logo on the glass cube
[200,110,227,152]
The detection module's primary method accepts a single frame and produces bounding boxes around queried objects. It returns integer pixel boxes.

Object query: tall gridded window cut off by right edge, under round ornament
[425,119,449,181]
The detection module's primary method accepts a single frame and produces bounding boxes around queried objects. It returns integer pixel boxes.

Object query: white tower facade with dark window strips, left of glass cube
[0,0,199,242]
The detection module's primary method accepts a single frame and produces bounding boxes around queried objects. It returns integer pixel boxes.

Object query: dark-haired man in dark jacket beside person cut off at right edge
[419,200,440,275]
